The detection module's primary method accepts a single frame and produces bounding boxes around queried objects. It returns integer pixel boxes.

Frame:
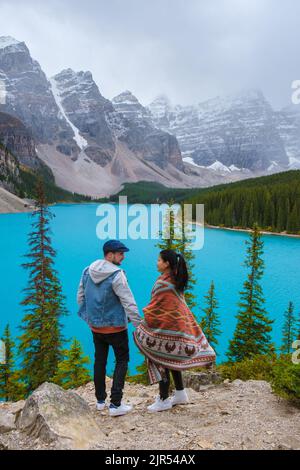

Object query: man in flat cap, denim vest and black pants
[77,240,142,416]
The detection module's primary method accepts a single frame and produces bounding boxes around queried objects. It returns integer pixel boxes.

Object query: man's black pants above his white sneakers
[93,330,129,406]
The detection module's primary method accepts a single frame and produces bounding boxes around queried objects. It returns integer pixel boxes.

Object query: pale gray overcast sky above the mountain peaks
[0,0,300,108]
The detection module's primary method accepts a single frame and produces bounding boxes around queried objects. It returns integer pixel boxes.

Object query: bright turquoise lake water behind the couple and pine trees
[0,204,300,374]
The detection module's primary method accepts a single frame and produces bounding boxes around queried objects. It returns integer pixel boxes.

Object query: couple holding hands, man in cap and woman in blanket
[77,240,215,416]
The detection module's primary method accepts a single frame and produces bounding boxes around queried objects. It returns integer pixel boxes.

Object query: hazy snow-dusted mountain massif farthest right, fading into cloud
[149,90,290,172]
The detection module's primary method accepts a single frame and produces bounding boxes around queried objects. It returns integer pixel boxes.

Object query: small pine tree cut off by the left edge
[0,325,25,401]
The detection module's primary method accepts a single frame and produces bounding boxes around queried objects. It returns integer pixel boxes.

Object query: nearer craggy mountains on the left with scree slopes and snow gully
[0,37,203,196]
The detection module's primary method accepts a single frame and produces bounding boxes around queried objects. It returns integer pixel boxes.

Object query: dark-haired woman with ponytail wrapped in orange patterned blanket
[134,250,216,412]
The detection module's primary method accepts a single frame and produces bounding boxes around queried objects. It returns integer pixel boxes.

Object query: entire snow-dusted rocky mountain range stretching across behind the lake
[0,36,300,196]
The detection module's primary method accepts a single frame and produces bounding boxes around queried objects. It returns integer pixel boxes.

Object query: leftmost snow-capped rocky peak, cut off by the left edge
[0,36,72,150]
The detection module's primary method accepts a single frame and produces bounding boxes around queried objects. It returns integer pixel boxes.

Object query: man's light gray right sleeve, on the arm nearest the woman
[112,271,142,327]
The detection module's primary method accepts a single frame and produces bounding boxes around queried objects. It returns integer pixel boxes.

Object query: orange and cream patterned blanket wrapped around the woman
[134,274,216,384]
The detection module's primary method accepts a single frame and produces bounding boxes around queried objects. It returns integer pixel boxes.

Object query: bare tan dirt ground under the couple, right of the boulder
[77,380,300,450]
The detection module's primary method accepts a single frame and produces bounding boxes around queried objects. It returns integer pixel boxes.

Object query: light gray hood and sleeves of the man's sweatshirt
[77,259,142,327]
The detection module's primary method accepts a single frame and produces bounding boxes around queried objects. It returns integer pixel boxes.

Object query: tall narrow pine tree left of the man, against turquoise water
[19,181,67,392]
